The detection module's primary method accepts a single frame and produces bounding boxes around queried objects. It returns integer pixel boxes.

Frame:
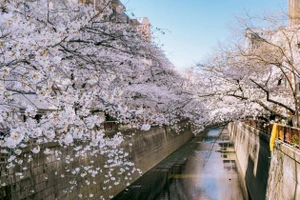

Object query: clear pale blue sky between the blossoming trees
[121,0,288,69]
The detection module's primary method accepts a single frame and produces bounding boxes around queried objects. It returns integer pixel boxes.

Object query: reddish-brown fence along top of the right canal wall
[244,120,300,148]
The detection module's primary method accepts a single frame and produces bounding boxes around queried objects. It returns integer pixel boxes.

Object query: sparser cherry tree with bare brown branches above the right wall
[192,9,299,124]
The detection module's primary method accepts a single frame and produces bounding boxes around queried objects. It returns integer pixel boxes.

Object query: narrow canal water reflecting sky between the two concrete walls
[114,128,245,200]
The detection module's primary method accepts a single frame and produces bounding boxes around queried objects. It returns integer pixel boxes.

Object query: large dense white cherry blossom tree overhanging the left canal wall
[0,0,191,198]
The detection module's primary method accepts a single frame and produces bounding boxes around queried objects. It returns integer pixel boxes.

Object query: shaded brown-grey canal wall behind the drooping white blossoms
[0,122,193,200]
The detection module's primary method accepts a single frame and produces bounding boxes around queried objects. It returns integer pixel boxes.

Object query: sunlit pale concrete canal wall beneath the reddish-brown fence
[228,122,300,200]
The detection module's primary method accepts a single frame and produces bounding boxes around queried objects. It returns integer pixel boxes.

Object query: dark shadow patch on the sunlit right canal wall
[245,133,271,200]
